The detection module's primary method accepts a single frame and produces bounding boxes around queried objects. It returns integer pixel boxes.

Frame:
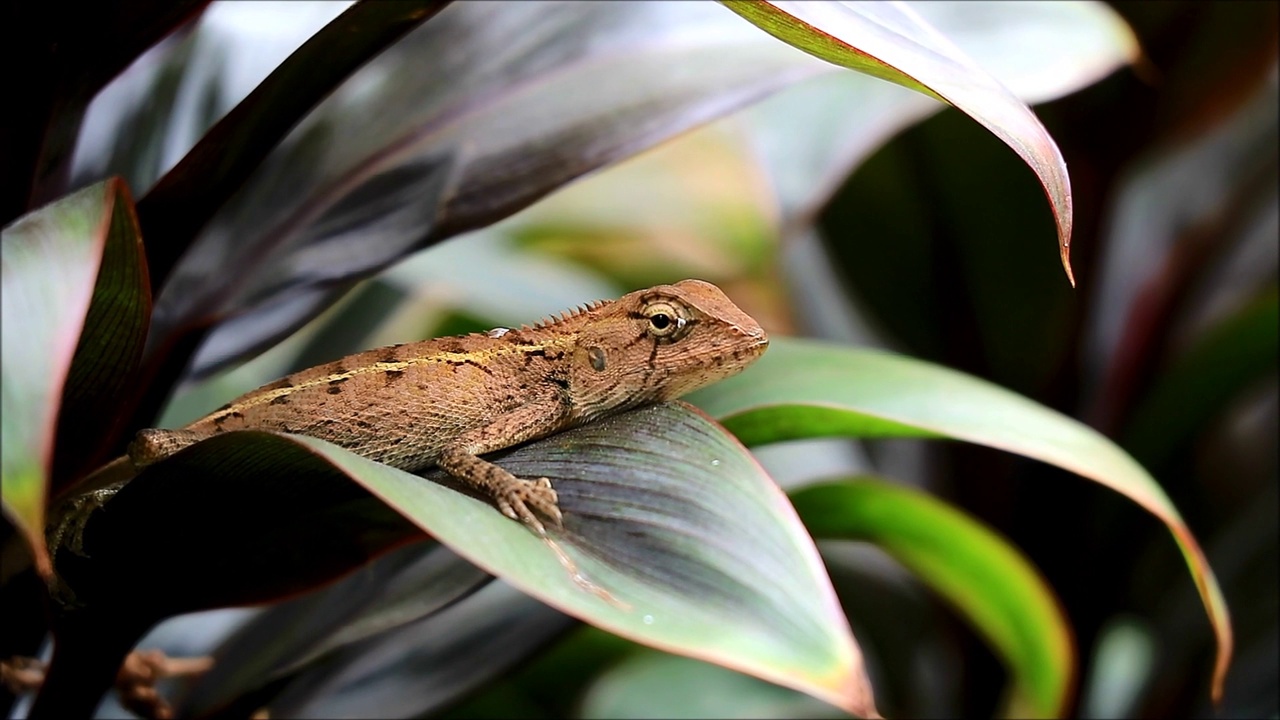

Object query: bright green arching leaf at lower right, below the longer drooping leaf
[791,478,1075,717]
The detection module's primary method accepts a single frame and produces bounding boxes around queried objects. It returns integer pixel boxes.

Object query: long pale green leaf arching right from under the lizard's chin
[690,340,1233,698]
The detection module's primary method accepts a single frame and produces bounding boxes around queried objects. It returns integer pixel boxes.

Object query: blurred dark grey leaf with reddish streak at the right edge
[1085,74,1280,430]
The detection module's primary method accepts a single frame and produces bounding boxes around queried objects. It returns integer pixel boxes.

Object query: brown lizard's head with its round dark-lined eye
[572,274,769,410]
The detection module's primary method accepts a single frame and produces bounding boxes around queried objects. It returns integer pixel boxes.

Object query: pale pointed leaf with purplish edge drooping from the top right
[724,0,1075,284]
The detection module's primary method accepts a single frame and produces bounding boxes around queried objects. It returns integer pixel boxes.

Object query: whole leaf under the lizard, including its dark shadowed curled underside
[59,404,874,715]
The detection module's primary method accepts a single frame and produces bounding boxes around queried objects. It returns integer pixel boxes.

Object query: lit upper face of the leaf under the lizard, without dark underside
[298,404,876,716]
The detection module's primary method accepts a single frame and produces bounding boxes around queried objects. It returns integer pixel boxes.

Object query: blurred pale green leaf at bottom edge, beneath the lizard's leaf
[575,651,849,719]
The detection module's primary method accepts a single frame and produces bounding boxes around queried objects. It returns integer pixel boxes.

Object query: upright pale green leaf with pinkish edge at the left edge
[0,179,145,575]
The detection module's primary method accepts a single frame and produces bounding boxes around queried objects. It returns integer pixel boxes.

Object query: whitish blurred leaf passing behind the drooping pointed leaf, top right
[735,0,1139,223]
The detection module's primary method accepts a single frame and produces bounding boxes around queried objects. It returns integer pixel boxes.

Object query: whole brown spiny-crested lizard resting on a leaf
[120,279,769,534]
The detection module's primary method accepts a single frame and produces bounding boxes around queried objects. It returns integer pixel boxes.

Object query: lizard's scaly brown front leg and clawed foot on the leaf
[436,401,563,536]
